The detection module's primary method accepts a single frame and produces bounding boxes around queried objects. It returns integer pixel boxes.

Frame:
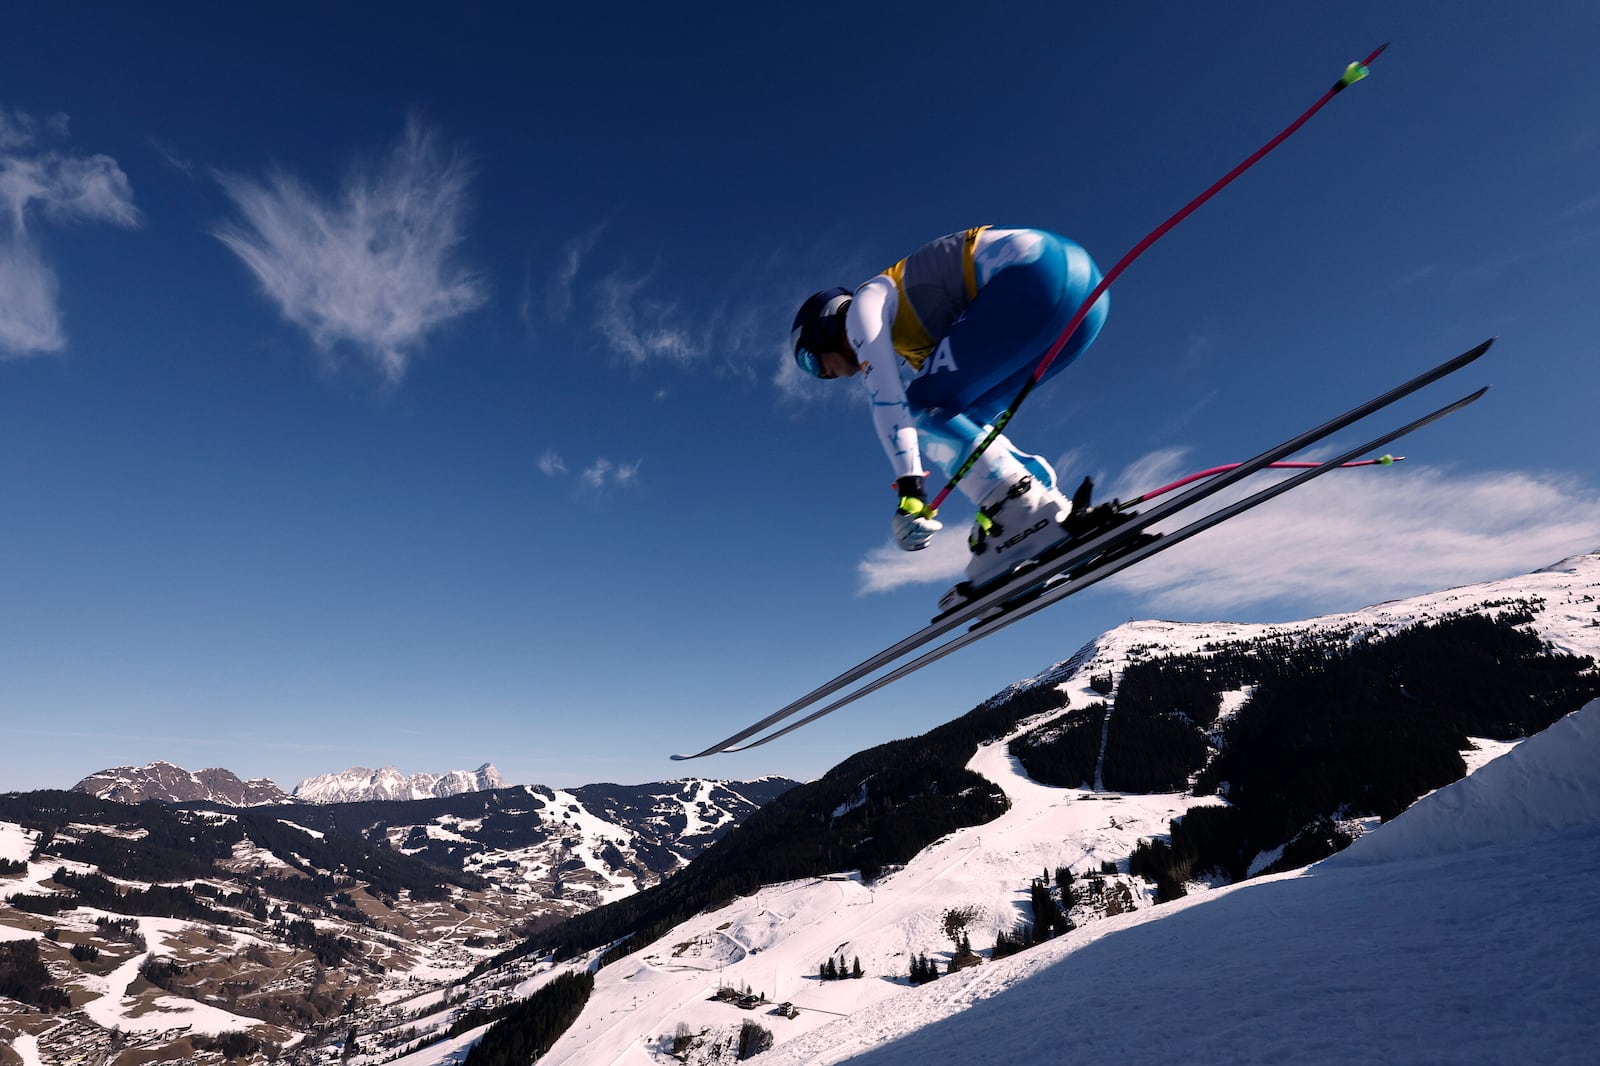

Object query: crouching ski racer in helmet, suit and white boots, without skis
[790,226,1110,587]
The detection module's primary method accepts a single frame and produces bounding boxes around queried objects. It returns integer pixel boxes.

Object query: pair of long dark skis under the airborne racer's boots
[672,338,1494,760]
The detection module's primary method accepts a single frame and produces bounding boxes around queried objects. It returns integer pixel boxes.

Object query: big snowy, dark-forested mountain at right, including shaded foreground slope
[467,555,1600,1066]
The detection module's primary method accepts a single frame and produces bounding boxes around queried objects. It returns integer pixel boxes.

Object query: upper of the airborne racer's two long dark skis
[672,338,1494,760]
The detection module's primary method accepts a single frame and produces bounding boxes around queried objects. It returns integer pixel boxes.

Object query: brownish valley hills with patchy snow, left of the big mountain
[0,778,794,1063]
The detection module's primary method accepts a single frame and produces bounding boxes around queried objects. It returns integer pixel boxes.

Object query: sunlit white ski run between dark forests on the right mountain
[534,704,1218,1066]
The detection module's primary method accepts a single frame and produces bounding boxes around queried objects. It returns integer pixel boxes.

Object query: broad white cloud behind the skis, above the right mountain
[858,450,1600,615]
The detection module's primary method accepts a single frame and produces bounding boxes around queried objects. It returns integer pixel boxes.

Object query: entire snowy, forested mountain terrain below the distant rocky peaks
[12,555,1600,1066]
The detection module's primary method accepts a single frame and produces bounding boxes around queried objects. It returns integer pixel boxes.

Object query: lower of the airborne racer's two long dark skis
[718,386,1490,754]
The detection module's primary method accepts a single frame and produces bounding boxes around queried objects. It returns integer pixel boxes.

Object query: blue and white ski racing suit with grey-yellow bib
[845,226,1110,506]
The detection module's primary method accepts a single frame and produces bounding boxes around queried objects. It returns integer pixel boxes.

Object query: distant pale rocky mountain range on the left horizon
[72,762,506,807]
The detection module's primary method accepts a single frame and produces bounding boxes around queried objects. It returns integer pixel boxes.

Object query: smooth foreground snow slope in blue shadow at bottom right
[762,701,1600,1066]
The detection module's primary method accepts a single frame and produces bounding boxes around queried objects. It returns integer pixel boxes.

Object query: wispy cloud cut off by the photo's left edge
[0,107,141,357]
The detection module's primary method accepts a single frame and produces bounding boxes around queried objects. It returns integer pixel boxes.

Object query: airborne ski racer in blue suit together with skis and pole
[674,45,1414,759]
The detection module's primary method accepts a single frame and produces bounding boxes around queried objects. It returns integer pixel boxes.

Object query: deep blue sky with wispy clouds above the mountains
[0,2,1600,789]
